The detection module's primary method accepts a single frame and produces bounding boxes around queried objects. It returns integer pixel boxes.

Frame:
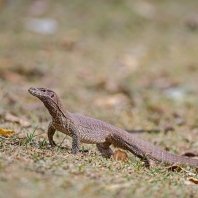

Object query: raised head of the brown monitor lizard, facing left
[28,87,58,103]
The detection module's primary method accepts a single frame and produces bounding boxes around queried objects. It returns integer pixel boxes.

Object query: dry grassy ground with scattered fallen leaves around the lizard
[0,0,198,198]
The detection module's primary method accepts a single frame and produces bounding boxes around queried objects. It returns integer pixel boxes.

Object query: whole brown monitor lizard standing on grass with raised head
[28,87,198,167]
